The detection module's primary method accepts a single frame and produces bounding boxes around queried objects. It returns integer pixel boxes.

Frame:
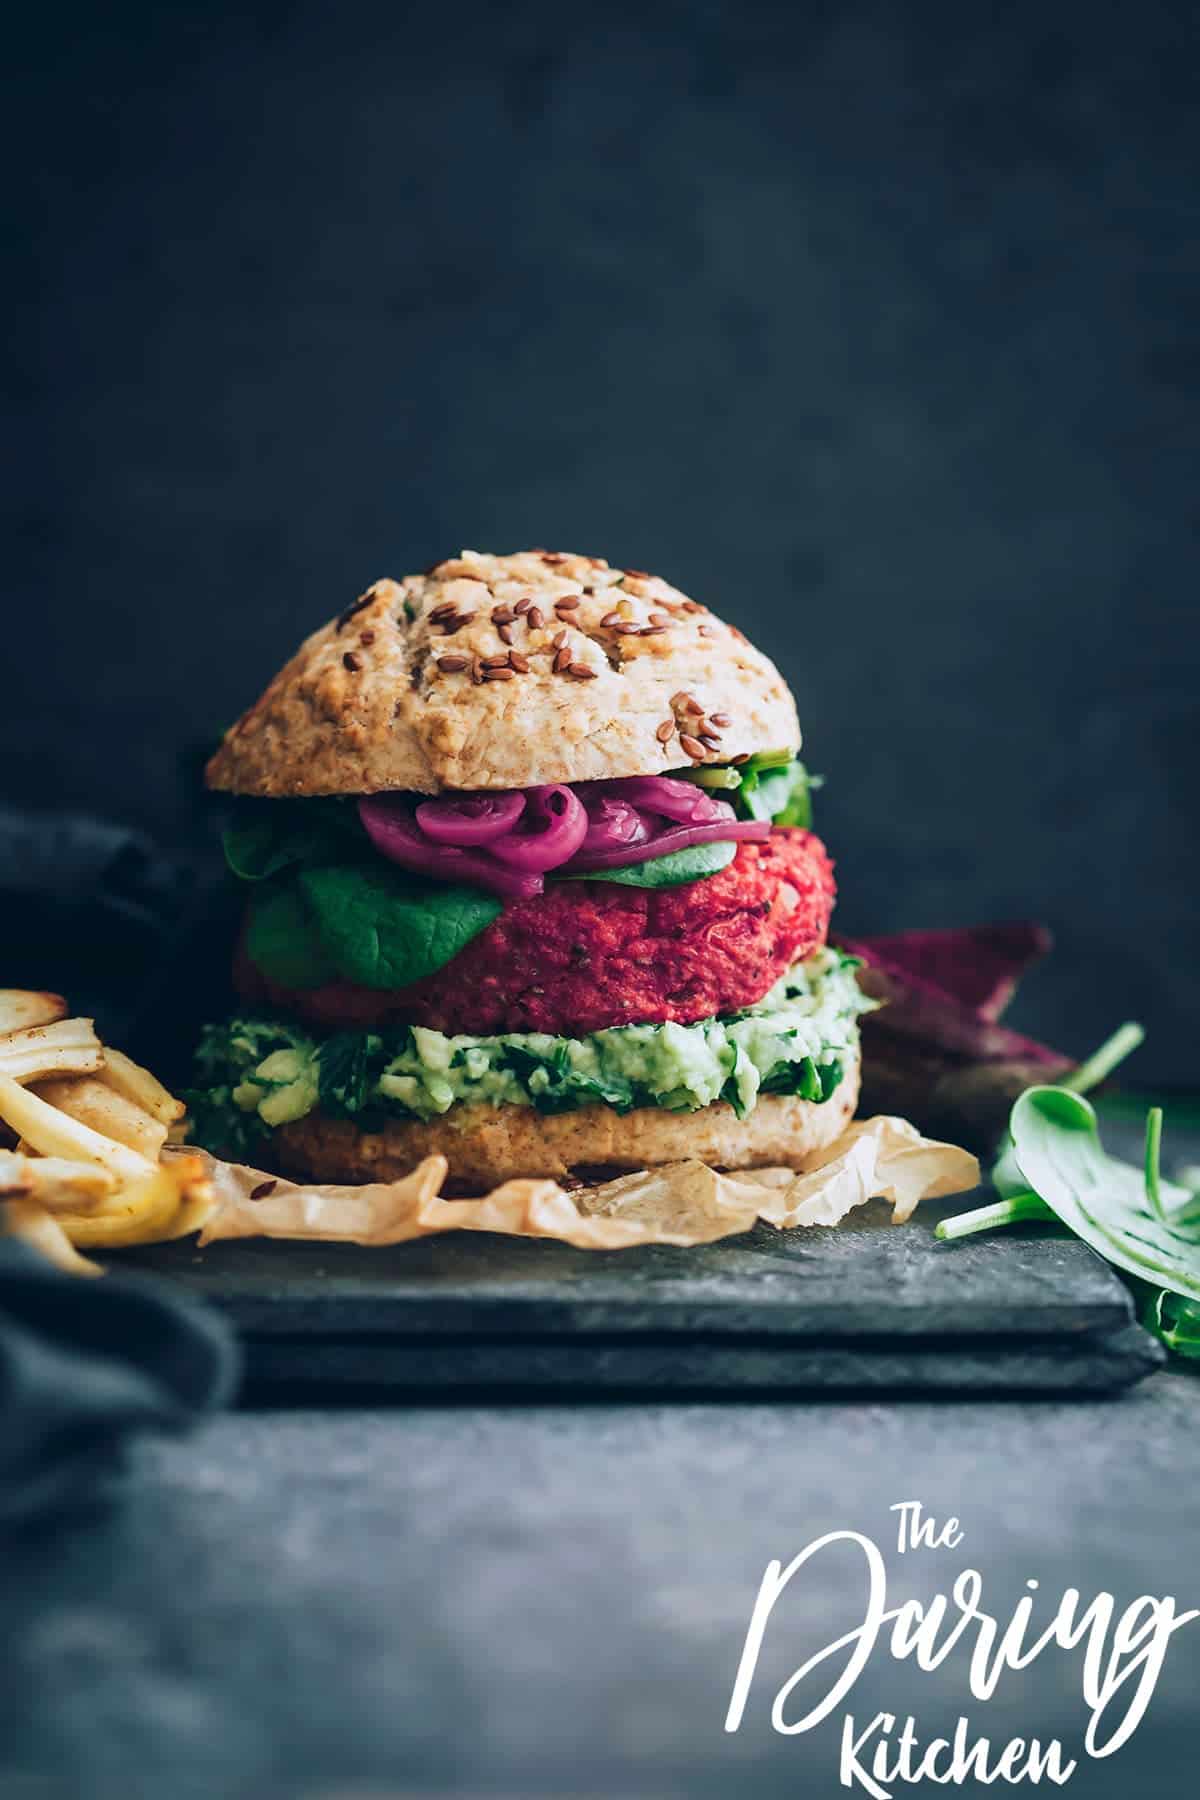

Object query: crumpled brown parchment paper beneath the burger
[200,1118,979,1249]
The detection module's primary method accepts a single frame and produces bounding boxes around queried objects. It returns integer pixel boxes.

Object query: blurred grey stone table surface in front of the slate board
[0,1366,1200,1800]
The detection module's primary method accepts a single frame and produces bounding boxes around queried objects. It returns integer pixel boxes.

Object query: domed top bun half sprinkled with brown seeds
[207,551,801,795]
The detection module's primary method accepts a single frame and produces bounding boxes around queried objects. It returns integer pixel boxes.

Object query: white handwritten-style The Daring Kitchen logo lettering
[725,1499,1200,1800]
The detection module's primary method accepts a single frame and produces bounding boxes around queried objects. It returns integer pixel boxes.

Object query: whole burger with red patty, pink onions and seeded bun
[191,551,871,1193]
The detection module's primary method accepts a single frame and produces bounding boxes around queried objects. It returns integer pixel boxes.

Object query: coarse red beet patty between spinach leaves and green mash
[236,830,835,1037]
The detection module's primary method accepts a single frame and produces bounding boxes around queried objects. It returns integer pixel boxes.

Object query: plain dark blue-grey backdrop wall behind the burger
[0,0,1200,1080]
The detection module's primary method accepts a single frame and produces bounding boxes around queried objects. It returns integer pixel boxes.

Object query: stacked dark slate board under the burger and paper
[113,1197,1162,1397]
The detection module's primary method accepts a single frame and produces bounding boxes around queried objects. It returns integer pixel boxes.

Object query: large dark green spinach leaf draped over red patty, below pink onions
[302,859,500,988]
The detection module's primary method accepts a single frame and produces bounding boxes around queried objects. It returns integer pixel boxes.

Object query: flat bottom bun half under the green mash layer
[275,1053,858,1193]
